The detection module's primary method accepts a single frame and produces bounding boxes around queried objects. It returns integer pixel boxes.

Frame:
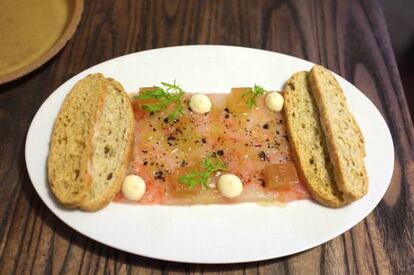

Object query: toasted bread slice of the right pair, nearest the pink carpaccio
[283,72,346,207]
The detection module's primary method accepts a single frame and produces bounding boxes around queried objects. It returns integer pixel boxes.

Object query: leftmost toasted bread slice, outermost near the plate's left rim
[48,74,106,207]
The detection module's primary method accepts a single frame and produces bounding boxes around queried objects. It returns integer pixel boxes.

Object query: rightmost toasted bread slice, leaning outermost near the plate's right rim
[309,66,368,201]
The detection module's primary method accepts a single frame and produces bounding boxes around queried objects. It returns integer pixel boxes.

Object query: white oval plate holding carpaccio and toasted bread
[26,46,394,263]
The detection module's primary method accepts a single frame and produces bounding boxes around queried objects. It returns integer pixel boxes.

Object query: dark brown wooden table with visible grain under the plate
[0,0,414,274]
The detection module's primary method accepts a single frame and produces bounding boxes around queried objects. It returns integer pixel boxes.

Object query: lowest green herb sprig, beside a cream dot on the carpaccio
[178,157,226,189]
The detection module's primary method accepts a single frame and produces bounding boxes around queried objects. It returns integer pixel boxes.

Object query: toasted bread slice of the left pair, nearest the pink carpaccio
[79,79,134,211]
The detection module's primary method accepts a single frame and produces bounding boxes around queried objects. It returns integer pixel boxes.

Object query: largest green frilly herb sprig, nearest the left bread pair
[134,80,185,122]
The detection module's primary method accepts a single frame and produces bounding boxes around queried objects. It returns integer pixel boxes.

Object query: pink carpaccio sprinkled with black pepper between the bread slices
[121,88,309,205]
